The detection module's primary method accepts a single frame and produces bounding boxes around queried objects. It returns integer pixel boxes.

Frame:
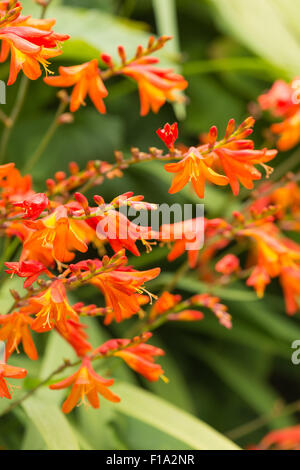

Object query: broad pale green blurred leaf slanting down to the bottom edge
[114,383,238,450]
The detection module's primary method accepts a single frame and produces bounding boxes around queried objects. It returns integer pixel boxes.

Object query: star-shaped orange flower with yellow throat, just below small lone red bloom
[165,147,229,199]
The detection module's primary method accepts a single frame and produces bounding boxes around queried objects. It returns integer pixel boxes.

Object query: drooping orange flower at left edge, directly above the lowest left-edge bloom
[0,310,38,360]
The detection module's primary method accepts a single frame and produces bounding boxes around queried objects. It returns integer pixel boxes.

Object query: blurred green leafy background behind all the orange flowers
[0,0,300,449]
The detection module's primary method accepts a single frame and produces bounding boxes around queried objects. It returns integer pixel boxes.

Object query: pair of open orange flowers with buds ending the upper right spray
[165,117,277,198]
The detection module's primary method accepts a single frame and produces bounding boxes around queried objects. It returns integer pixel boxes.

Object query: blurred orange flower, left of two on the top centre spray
[44,59,108,114]
